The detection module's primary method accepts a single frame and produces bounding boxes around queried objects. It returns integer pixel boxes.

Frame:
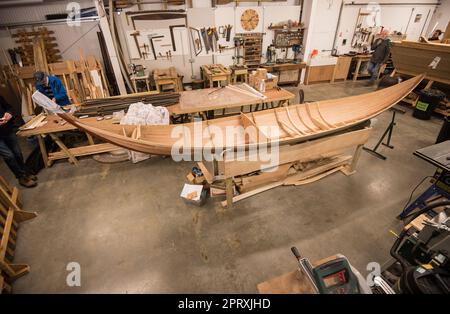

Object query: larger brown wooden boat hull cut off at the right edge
[391,41,450,84]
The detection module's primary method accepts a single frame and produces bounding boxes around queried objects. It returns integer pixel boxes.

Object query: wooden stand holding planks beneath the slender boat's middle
[214,128,372,208]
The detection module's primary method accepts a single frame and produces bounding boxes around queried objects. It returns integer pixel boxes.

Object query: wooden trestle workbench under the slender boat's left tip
[17,115,121,167]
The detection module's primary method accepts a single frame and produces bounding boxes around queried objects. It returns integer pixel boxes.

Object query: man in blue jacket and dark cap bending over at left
[34,71,70,107]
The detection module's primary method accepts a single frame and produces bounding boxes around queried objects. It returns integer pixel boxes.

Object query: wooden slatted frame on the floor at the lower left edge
[0,177,37,293]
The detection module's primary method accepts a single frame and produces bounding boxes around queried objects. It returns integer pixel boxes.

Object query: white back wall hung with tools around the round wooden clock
[116,1,300,83]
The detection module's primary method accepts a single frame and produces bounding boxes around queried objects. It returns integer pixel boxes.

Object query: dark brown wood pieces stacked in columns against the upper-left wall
[12,27,61,66]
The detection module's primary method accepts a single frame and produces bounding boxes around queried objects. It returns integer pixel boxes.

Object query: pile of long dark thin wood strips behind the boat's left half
[75,93,180,116]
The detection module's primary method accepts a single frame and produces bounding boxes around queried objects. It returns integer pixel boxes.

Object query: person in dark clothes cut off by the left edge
[0,96,37,188]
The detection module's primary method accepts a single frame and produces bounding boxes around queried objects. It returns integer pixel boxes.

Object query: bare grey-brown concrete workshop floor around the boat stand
[0,82,442,293]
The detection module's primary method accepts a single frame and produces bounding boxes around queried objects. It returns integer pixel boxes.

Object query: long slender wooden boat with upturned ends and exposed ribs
[58,75,423,155]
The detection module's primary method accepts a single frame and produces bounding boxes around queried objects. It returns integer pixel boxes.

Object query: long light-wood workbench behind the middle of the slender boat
[166,87,295,115]
